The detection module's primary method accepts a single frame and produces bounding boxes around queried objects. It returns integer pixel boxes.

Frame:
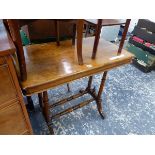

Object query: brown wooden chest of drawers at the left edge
[0,24,32,134]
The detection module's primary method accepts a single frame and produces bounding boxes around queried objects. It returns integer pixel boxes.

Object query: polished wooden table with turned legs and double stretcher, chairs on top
[1,20,133,133]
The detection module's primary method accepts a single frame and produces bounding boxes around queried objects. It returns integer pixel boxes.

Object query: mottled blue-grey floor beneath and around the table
[30,65,155,135]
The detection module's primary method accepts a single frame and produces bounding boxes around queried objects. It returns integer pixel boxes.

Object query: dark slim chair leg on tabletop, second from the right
[92,19,102,59]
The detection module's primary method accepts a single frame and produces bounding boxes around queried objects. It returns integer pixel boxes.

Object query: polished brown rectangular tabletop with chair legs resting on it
[21,37,133,95]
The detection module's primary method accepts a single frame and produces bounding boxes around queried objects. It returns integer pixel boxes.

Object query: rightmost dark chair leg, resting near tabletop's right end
[117,19,131,55]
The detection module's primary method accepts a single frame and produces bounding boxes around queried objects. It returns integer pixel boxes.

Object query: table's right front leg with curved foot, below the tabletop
[96,71,107,119]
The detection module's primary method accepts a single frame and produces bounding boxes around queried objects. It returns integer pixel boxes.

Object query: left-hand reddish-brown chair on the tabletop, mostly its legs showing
[7,19,84,77]
